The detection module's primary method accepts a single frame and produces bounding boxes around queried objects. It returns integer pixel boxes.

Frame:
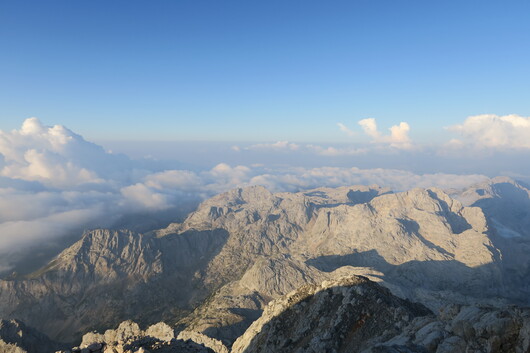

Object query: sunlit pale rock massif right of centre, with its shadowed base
[294,189,502,306]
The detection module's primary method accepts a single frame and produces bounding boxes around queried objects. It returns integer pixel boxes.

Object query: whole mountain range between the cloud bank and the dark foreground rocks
[0,178,530,348]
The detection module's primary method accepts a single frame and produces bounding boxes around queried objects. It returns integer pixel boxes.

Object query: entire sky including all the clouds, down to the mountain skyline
[0,0,530,273]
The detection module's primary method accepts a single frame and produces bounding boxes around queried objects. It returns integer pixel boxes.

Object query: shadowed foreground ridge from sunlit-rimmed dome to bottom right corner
[232,277,530,353]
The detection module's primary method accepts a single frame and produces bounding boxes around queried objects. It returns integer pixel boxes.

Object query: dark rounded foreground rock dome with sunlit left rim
[232,277,430,353]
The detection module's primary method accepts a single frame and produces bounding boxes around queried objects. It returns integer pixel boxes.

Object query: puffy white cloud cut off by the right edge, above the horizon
[447,114,530,149]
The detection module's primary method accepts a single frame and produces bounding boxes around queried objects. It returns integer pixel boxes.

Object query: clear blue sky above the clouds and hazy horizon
[0,0,530,141]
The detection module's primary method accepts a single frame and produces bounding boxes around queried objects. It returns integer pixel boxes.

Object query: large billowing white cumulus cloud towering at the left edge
[0,118,130,188]
